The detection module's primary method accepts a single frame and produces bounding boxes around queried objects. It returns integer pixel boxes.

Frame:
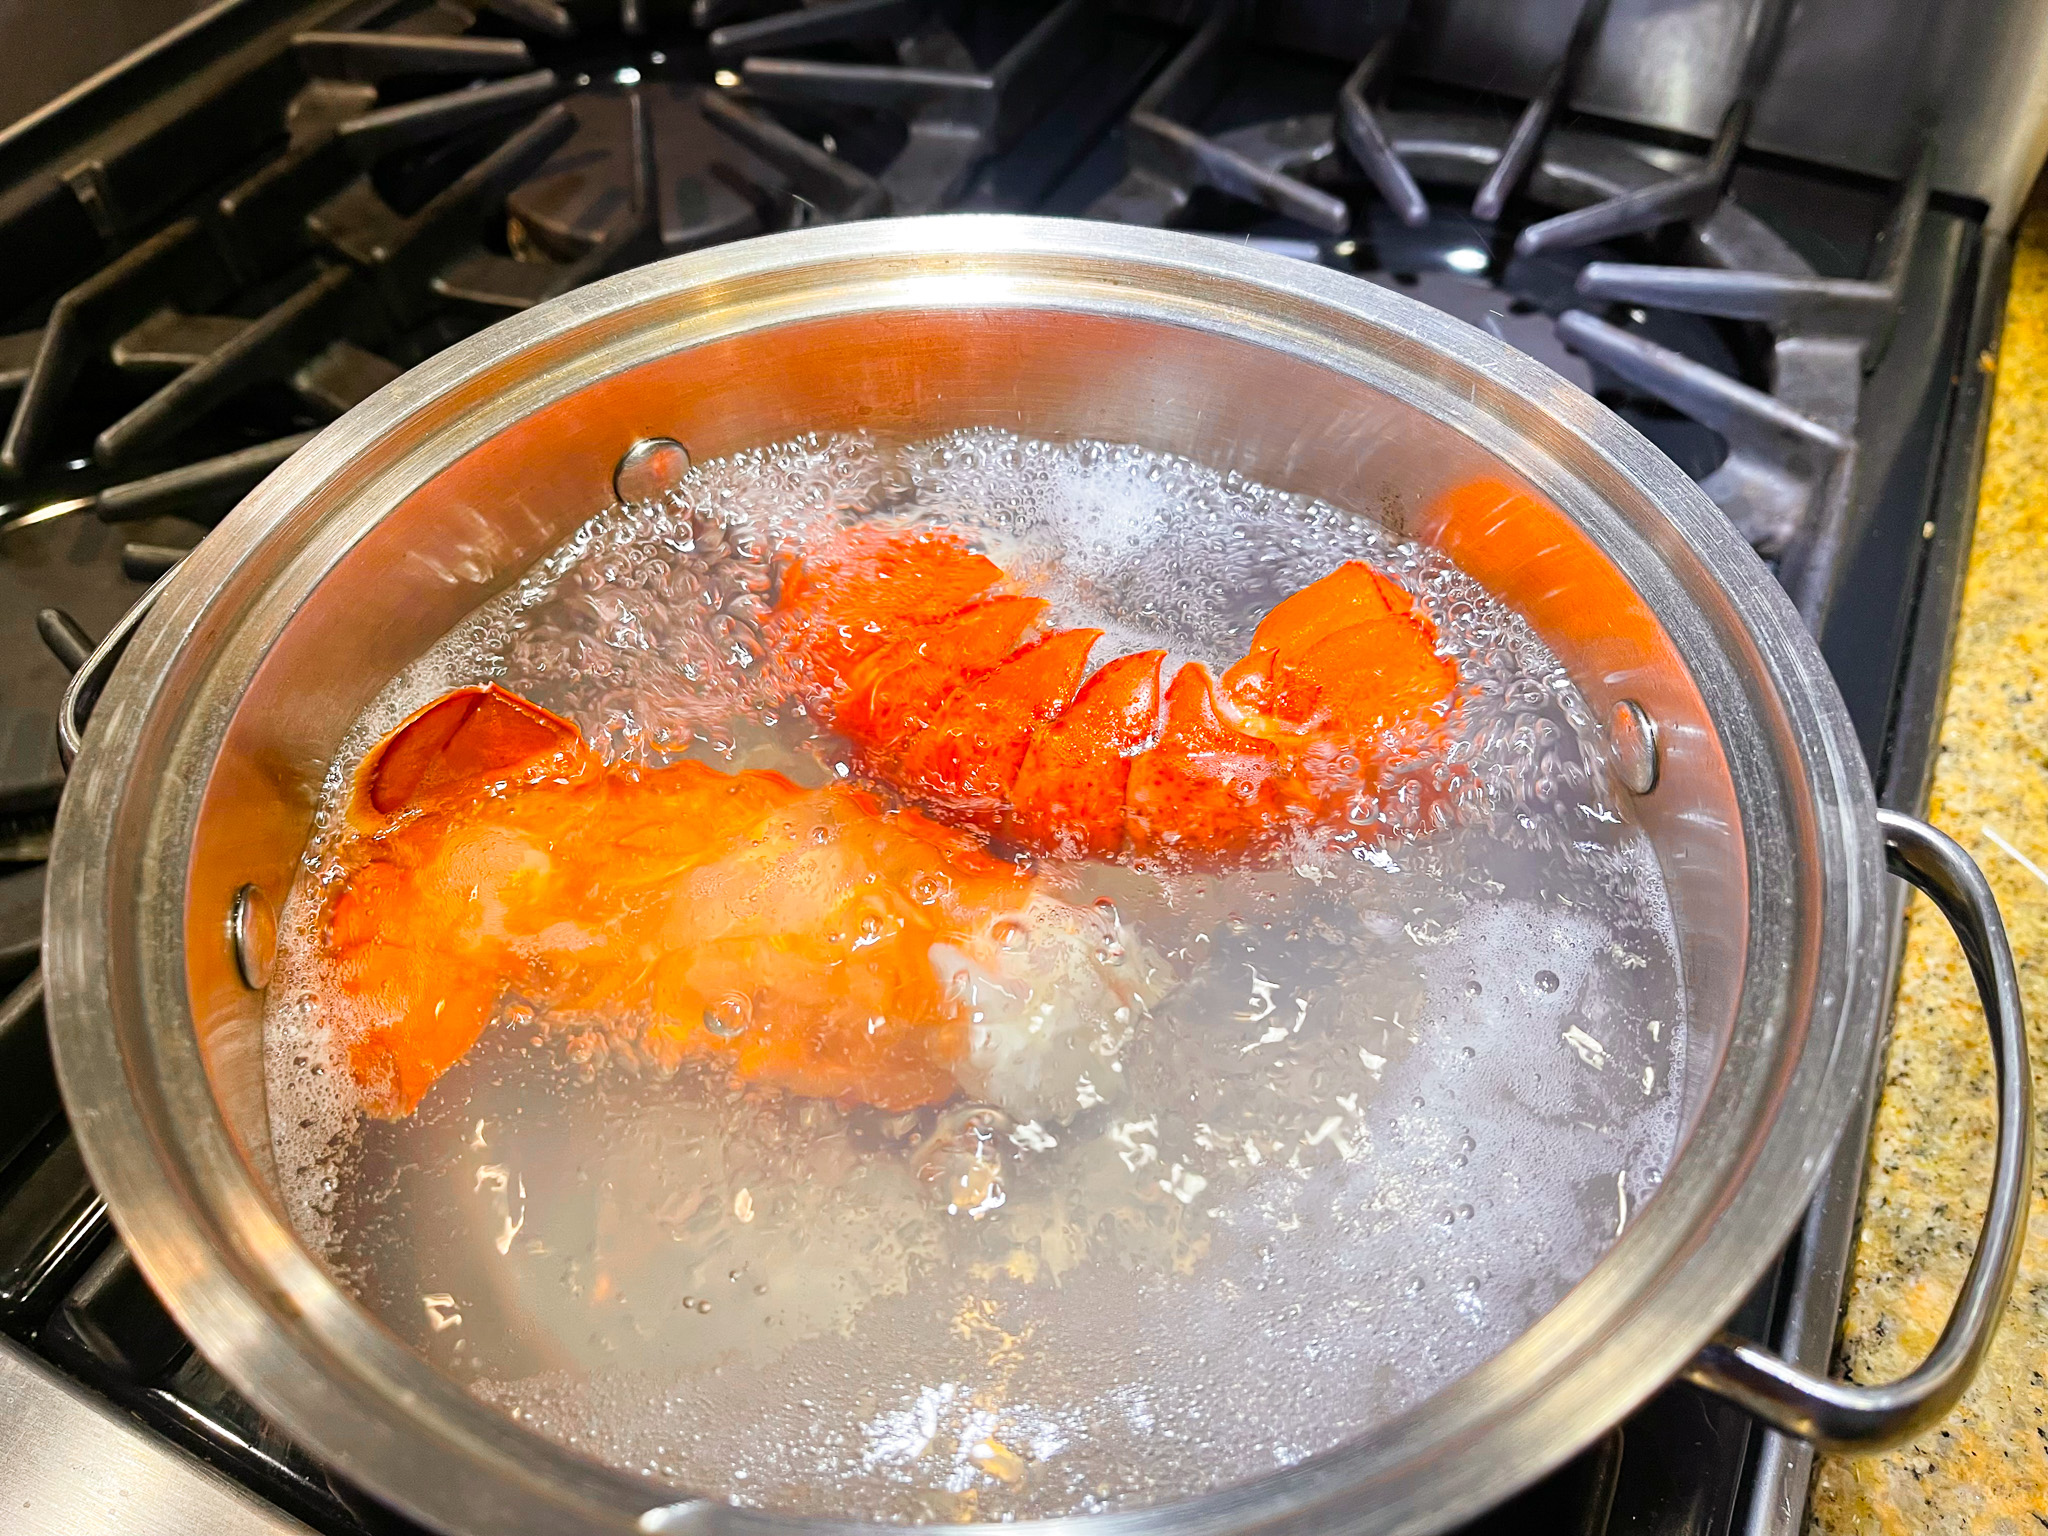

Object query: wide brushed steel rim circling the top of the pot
[43,215,1882,1536]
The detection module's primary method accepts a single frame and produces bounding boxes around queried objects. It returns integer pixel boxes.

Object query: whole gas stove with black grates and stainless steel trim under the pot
[0,0,2044,1536]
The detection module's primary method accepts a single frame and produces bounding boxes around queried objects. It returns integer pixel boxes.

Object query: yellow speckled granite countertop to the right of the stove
[1808,201,2048,1536]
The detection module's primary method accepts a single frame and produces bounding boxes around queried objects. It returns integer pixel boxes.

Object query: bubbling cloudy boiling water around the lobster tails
[268,432,1686,1520]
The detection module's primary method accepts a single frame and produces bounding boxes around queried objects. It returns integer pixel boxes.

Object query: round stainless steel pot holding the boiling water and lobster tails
[45,217,2032,1532]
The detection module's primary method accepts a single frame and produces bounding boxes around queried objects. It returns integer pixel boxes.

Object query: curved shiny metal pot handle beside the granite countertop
[1683,811,2034,1452]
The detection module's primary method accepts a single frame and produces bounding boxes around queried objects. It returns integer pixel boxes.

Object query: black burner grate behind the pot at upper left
[0,0,1138,563]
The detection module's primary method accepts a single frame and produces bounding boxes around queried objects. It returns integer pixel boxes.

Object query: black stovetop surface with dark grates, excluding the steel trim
[0,0,2003,1534]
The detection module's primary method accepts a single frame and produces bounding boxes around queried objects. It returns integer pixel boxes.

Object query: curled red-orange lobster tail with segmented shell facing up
[782,526,1458,860]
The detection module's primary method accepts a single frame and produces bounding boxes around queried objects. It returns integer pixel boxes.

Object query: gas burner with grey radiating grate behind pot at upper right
[1090,67,1931,623]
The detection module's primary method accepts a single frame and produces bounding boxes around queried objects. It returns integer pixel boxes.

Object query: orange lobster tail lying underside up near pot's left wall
[326,688,1032,1116]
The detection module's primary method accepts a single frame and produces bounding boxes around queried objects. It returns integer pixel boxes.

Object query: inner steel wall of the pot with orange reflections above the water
[186,303,1747,1228]
